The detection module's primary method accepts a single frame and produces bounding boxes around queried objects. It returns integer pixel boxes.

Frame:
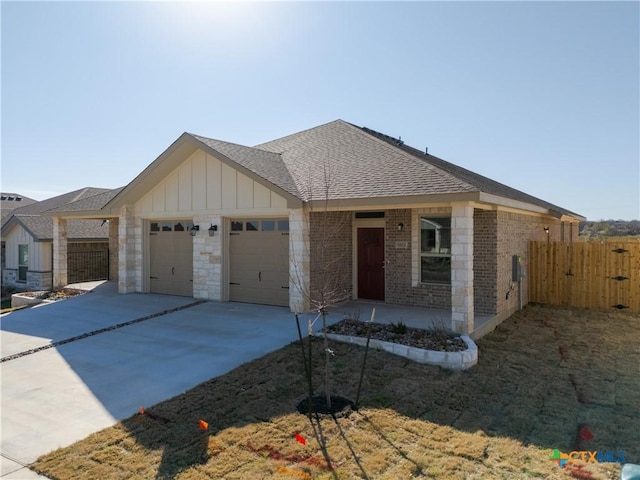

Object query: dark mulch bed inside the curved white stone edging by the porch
[327,319,467,352]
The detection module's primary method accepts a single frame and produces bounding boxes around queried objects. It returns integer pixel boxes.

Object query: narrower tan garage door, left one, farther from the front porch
[149,220,193,297]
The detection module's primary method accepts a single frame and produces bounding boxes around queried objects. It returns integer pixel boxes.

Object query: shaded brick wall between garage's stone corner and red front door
[309,212,353,303]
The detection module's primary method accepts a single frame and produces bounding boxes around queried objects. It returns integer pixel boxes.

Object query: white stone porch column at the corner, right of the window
[451,205,473,333]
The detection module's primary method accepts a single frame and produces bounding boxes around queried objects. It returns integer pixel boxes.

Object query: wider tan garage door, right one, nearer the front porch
[229,218,289,306]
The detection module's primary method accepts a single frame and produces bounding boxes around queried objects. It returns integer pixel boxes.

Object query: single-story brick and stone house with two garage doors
[48,120,584,332]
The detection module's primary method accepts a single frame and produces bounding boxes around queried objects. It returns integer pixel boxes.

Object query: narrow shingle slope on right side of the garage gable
[190,134,300,198]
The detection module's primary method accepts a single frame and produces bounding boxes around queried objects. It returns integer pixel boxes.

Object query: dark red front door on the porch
[358,228,384,300]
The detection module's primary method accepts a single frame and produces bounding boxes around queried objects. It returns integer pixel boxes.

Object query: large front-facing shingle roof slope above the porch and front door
[256,120,475,200]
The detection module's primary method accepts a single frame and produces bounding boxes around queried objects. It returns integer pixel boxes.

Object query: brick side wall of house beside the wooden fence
[496,211,564,318]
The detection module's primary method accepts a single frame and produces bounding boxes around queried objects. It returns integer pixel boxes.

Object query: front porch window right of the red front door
[420,217,451,284]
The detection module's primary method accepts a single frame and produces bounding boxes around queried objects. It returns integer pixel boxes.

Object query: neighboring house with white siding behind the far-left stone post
[2,188,110,290]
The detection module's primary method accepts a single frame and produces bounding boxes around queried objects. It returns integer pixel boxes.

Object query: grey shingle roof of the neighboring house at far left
[2,187,112,242]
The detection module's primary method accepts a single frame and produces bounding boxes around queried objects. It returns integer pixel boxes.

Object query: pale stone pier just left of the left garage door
[118,206,142,293]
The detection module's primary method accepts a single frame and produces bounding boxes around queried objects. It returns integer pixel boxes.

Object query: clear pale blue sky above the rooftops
[1,1,640,220]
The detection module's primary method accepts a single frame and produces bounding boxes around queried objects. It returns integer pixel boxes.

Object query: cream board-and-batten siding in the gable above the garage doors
[136,150,288,218]
